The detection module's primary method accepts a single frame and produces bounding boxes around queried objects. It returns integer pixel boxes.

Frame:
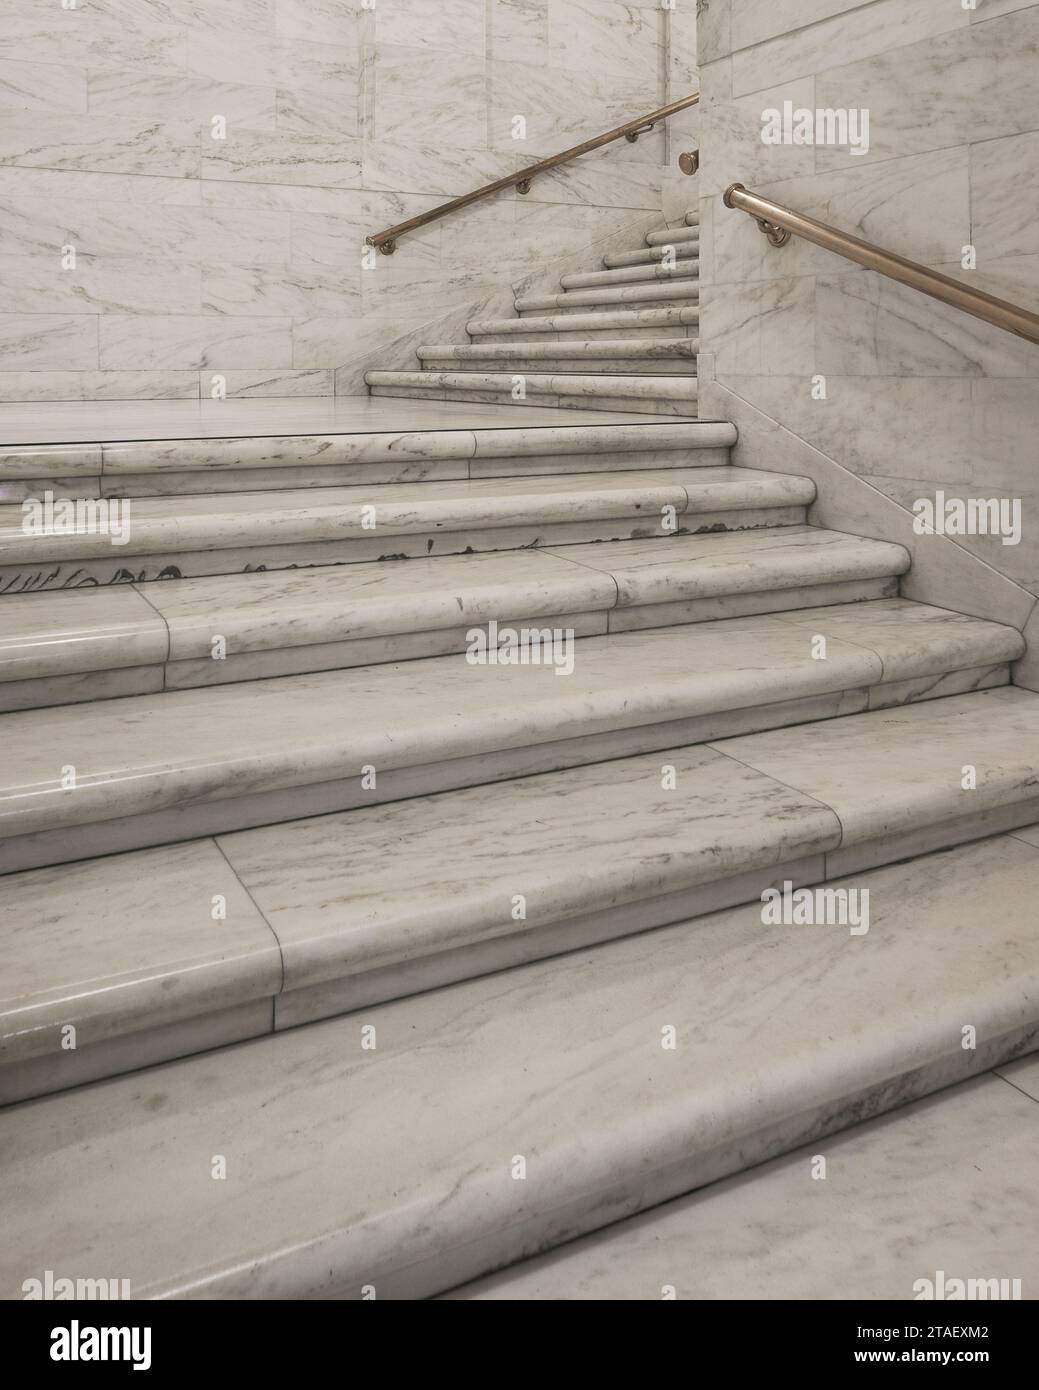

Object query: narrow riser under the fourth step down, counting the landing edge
[0,664,1018,873]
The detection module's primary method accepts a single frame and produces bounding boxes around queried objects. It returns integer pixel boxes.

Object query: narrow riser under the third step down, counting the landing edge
[0,567,899,713]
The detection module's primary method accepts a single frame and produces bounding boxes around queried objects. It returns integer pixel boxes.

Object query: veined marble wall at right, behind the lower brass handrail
[700,0,1039,606]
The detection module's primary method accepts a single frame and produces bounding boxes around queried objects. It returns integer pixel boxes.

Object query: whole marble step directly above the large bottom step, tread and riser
[0,678,1039,1102]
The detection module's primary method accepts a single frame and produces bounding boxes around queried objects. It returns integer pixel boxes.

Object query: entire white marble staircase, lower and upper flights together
[0,208,1039,1298]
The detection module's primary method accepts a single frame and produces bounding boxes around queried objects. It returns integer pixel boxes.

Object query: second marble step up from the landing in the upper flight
[416,336,700,377]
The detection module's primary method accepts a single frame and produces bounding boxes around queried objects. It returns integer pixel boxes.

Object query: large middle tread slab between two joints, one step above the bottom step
[220,748,840,990]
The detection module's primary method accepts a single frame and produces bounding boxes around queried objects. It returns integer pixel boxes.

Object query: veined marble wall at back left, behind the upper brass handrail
[0,0,695,400]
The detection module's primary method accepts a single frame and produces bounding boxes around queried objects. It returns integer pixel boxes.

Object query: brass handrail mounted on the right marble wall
[722,183,1039,343]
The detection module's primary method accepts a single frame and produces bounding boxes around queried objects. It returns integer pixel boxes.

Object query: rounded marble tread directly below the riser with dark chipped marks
[0,522,908,681]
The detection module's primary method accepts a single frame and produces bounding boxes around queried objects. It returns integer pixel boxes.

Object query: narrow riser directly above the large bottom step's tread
[0,772,1039,1105]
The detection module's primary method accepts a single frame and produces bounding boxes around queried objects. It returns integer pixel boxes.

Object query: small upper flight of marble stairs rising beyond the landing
[364,213,700,416]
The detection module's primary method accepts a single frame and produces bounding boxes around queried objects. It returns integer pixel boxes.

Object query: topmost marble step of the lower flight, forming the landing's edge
[0,419,736,503]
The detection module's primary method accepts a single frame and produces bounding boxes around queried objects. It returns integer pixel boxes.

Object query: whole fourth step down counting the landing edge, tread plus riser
[0,599,1024,873]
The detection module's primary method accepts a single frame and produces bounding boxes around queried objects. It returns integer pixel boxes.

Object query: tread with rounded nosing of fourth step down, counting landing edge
[0,600,1024,838]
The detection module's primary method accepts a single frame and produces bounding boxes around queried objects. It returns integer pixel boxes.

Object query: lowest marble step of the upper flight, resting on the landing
[364,368,697,416]
